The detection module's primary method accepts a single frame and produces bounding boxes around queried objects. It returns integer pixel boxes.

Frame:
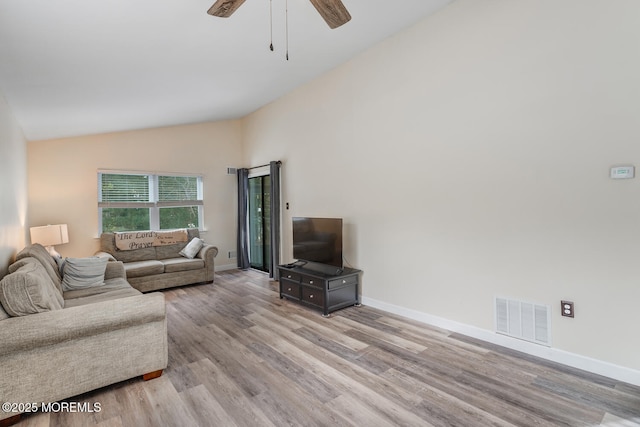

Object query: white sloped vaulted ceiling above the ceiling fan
[0,0,452,140]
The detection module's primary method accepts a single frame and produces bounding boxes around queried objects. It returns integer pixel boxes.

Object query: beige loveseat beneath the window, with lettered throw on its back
[96,228,218,292]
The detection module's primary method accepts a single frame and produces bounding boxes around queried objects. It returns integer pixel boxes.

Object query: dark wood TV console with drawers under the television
[278,265,361,317]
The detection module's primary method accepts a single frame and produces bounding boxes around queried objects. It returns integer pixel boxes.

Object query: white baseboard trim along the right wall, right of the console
[361,297,640,386]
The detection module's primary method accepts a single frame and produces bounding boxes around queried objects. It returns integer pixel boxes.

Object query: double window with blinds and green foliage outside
[98,171,203,232]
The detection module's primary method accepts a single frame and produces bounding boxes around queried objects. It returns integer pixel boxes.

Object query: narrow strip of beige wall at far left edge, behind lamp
[0,94,27,277]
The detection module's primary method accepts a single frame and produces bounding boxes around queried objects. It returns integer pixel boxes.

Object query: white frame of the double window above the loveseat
[97,169,204,234]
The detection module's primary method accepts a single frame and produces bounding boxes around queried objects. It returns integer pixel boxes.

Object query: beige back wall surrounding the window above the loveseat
[28,121,242,269]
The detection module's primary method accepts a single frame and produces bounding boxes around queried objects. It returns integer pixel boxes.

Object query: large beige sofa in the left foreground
[0,244,168,425]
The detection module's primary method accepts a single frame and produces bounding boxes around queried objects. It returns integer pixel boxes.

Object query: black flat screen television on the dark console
[293,217,342,269]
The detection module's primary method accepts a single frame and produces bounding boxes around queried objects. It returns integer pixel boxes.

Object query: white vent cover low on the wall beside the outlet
[496,297,551,346]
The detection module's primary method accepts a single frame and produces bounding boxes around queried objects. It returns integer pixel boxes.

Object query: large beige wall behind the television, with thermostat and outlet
[243,0,640,370]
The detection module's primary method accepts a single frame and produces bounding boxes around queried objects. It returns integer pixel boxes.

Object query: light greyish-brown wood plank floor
[13,271,640,427]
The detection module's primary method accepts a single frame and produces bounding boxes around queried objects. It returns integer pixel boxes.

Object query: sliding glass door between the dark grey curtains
[248,175,271,271]
